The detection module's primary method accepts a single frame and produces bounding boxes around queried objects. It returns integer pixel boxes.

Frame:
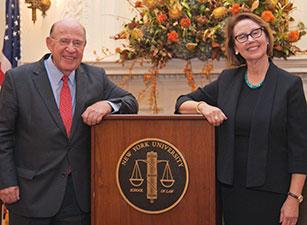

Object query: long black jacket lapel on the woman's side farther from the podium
[247,63,278,187]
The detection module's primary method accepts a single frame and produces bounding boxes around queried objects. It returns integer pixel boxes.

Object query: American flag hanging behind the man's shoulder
[0,0,20,85]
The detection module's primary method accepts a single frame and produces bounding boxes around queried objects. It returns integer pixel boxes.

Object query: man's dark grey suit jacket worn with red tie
[0,55,138,217]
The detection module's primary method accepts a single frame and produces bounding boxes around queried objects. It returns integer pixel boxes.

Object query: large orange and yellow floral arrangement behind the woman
[115,0,306,68]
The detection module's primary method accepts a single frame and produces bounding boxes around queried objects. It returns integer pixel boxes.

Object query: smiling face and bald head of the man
[46,20,86,75]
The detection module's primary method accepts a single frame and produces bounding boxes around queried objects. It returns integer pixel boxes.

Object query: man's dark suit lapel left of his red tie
[32,57,66,135]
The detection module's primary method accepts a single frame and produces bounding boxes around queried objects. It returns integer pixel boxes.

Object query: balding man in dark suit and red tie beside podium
[0,19,138,225]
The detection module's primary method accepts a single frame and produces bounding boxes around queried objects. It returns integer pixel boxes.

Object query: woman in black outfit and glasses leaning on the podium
[176,13,307,225]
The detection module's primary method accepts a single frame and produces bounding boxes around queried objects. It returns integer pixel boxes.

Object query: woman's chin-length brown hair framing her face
[225,13,274,66]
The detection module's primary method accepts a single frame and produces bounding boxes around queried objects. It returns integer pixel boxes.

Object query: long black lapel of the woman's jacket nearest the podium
[217,67,246,184]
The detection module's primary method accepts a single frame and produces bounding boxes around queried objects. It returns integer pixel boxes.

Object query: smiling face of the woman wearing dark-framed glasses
[233,19,268,63]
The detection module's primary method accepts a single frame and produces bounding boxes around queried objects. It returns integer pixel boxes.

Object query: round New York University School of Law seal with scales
[116,138,189,214]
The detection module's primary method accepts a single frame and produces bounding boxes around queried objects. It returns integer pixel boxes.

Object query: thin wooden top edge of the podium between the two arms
[103,114,206,120]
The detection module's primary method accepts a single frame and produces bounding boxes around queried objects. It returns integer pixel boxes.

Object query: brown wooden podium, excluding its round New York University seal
[91,115,216,225]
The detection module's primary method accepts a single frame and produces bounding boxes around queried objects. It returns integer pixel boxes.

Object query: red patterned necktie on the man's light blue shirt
[60,75,72,137]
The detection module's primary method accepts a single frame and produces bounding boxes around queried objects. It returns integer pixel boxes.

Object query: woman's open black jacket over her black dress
[176,62,307,193]
